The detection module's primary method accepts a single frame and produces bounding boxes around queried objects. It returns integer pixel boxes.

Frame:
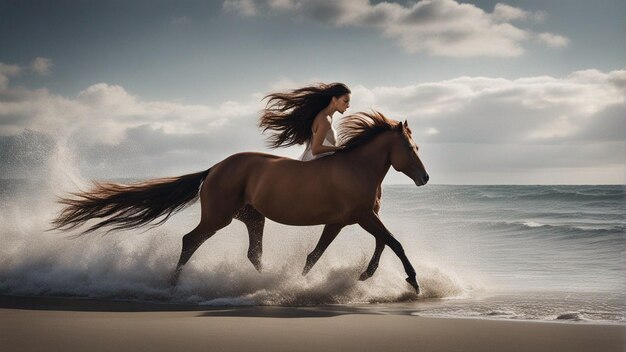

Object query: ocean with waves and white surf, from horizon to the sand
[0,180,626,324]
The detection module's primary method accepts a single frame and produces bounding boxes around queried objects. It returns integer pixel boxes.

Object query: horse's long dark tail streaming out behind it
[52,168,211,235]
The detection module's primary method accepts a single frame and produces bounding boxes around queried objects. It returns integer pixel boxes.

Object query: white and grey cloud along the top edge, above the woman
[223,0,568,57]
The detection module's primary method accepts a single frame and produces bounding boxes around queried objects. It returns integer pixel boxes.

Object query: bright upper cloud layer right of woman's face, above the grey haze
[352,70,626,144]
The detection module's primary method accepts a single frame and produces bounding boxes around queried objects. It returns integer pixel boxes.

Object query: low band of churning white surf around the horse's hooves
[0,204,472,305]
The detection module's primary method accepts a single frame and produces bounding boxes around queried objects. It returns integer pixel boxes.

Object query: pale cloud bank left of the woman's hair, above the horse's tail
[0,69,263,178]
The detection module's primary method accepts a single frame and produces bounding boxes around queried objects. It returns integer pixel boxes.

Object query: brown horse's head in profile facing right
[391,121,429,186]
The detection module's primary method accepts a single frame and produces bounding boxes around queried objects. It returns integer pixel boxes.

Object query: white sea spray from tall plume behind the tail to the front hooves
[0,137,472,305]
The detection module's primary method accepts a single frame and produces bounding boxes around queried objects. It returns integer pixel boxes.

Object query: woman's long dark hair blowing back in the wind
[259,83,351,148]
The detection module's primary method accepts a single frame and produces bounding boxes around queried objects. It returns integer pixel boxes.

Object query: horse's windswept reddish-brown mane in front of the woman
[338,110,399,149]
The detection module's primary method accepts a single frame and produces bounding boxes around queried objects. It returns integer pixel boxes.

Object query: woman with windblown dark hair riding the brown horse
[259,83,351,161]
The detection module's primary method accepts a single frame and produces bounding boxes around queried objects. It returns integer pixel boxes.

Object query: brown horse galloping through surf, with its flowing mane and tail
[53,112,428,293]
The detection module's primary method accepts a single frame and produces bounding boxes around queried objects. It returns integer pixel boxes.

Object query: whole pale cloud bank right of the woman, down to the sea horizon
[352,70,626,184]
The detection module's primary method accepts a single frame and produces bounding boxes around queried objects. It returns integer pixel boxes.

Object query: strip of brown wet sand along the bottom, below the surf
[0,296,626,352]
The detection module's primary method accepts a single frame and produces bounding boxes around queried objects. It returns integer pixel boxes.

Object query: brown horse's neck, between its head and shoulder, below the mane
[346,132,392,186]
